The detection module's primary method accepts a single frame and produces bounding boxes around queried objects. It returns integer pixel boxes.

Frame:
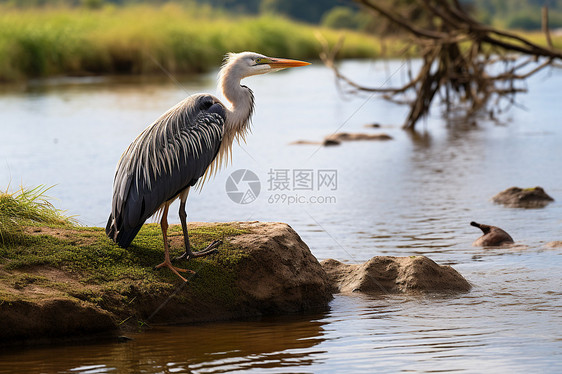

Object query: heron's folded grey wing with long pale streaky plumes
[106,95,226,247]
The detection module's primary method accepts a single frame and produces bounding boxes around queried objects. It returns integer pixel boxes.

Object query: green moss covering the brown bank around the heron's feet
[0,224,246,316]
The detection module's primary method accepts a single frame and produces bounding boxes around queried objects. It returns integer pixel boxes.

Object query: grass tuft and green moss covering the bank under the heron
[0,186,244,314]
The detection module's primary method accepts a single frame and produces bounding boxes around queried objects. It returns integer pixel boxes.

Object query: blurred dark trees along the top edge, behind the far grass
[0,0,562,33]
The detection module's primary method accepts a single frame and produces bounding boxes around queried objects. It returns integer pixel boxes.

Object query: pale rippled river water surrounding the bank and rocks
[0,61,562,373]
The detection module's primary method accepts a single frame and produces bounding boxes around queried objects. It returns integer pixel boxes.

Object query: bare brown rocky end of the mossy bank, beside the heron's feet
[231,222,332,314]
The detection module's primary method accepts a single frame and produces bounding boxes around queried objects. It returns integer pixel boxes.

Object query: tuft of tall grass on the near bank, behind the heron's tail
[0,186,74,244]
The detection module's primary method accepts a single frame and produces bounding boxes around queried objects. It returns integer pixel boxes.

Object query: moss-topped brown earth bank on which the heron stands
[0,222,332,343]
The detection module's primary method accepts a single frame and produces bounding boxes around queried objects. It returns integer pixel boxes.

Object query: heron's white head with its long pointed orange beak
[223,52,310,79]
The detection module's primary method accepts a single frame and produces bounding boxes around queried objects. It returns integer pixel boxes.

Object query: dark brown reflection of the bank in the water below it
[0,316,327,373]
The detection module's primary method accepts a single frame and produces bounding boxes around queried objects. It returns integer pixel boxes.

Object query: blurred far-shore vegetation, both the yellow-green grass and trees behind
[0,0,562,82]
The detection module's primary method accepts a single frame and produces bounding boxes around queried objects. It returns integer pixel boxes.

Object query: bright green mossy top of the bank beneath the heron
[0,224,248,301]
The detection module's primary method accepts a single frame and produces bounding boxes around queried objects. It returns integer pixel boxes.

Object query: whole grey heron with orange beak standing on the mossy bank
[105,52,310,282]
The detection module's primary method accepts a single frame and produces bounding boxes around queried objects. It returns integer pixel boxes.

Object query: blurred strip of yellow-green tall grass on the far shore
[0,4,380,81]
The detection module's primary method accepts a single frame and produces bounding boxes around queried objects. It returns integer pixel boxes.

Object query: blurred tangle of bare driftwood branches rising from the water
[321,0,562,129]
